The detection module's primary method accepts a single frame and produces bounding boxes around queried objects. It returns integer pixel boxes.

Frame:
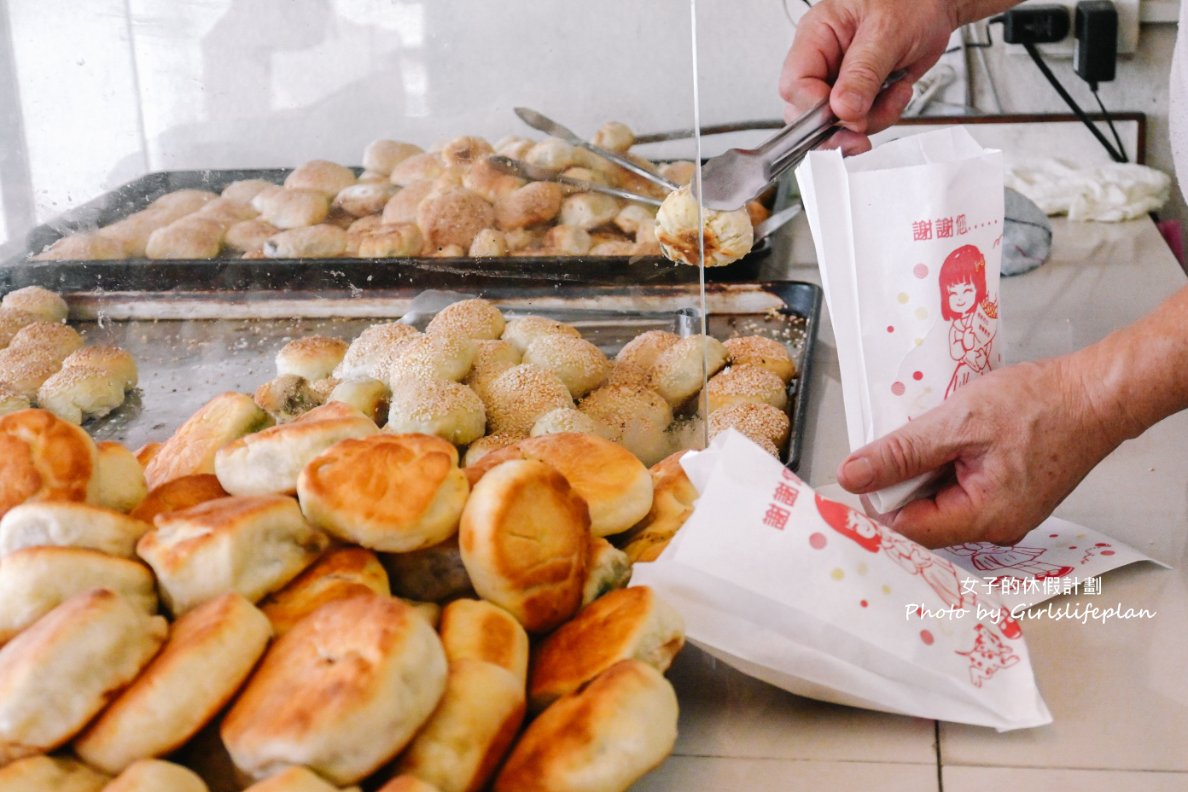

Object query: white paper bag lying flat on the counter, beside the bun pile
[633,431,1050,729]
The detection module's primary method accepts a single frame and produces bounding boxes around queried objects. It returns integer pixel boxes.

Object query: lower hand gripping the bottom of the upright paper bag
[838,357,1130,547]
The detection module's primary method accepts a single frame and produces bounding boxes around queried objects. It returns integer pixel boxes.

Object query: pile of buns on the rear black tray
[34,122,769,260]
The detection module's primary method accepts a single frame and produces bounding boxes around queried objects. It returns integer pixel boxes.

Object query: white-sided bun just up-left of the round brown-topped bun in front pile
[215,401,379,495]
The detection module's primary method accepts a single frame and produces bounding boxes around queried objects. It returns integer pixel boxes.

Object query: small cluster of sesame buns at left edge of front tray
[0,281,137,424]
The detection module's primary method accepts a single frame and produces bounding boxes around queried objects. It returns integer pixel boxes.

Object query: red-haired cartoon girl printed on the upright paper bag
[940,245,998,399]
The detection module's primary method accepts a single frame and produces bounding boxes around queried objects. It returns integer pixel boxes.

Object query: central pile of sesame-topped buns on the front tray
[255,298,797,464]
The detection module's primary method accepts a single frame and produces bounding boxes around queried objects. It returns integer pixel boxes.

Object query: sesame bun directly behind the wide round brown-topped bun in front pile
[386,378,487,445]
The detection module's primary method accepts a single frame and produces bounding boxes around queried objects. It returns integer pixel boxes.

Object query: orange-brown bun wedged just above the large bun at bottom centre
[260,546,392,635]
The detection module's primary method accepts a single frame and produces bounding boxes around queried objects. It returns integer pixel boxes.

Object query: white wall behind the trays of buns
[0,0,1184,250]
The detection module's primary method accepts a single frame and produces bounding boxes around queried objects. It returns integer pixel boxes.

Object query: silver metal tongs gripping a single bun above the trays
[701,70,906,210]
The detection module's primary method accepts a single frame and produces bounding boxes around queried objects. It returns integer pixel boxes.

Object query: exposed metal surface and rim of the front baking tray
[79,281,821,470]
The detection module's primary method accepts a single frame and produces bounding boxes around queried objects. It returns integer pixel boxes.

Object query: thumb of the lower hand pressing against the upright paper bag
[838,413,955,493]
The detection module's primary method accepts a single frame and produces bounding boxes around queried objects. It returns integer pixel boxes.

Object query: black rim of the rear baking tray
[0,169,771,292]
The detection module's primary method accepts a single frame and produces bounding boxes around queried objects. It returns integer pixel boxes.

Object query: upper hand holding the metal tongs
[779,0,963,153]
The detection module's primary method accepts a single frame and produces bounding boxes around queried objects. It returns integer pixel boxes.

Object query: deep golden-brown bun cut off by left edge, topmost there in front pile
[0,410,99,515]
